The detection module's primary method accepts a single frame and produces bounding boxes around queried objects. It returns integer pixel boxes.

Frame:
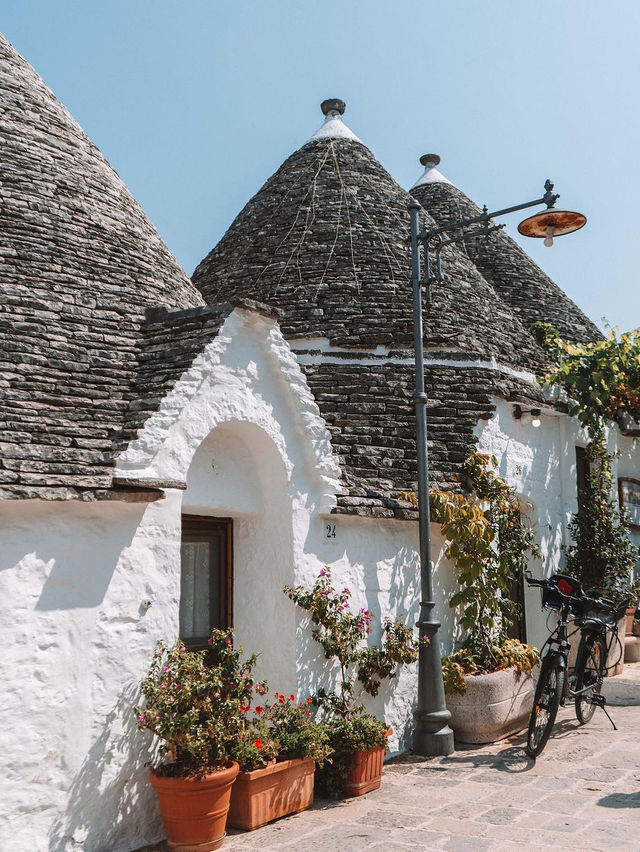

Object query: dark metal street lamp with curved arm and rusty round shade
[409,176,587,756]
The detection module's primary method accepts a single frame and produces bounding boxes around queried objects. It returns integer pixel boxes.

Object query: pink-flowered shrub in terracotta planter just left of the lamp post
[284,568,418,798]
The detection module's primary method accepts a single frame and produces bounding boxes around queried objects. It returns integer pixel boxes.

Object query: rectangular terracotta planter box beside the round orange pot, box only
[227,758,315,831]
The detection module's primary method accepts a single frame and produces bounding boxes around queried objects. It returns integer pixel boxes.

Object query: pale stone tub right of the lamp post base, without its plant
[446,668,533,743]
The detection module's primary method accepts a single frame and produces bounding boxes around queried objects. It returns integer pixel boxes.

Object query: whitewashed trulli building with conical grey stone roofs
[0,33,640,852]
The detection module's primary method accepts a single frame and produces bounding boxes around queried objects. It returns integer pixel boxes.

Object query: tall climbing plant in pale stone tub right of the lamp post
[431,452,539,743]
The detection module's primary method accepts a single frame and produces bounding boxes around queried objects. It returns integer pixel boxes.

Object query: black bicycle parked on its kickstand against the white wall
[525,574,629,757]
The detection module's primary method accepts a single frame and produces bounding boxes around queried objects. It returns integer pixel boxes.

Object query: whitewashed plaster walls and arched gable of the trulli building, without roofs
[0,309,640,852]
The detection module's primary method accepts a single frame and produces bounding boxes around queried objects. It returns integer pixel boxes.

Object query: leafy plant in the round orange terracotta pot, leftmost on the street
[134,630,264,852]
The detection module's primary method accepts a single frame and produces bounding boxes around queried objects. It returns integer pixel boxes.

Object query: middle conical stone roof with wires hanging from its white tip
[193,102,543,369]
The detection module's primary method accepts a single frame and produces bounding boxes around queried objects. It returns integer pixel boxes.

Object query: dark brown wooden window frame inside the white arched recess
[178,514,233,650]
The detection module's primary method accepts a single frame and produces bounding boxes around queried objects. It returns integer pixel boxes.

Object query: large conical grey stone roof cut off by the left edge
[0,36,203,498]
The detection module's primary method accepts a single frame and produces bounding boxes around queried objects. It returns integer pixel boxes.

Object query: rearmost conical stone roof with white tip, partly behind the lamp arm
[411,154,602,343]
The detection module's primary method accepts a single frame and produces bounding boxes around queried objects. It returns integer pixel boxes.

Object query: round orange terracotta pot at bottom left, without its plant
[149,762,239,852]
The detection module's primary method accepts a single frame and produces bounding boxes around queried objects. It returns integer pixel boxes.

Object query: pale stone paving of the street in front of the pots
[140,680,640,852]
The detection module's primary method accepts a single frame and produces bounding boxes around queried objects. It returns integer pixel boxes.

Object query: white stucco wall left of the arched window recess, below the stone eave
[0,492,181,852]
